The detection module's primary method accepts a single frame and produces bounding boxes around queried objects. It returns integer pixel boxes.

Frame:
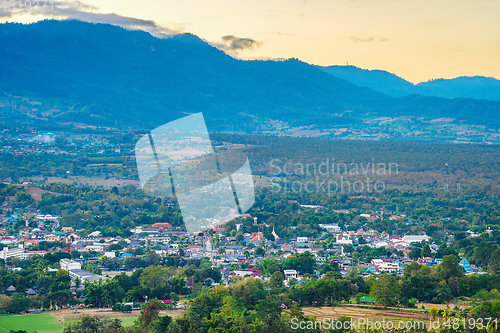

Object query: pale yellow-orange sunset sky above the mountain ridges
[0,0,500,83]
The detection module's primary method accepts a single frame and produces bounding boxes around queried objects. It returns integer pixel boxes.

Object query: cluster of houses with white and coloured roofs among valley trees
[0,210,484,280]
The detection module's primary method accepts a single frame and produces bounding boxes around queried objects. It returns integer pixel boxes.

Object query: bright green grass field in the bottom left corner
[0,313,63,333]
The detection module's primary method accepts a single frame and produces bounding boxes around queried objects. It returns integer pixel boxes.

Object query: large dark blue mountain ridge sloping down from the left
[0,20,500,139]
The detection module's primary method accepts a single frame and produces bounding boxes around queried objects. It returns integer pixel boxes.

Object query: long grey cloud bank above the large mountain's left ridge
[0,0,182,37]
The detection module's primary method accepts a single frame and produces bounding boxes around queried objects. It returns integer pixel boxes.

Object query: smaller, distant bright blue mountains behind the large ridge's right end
[318,66,500,101]
